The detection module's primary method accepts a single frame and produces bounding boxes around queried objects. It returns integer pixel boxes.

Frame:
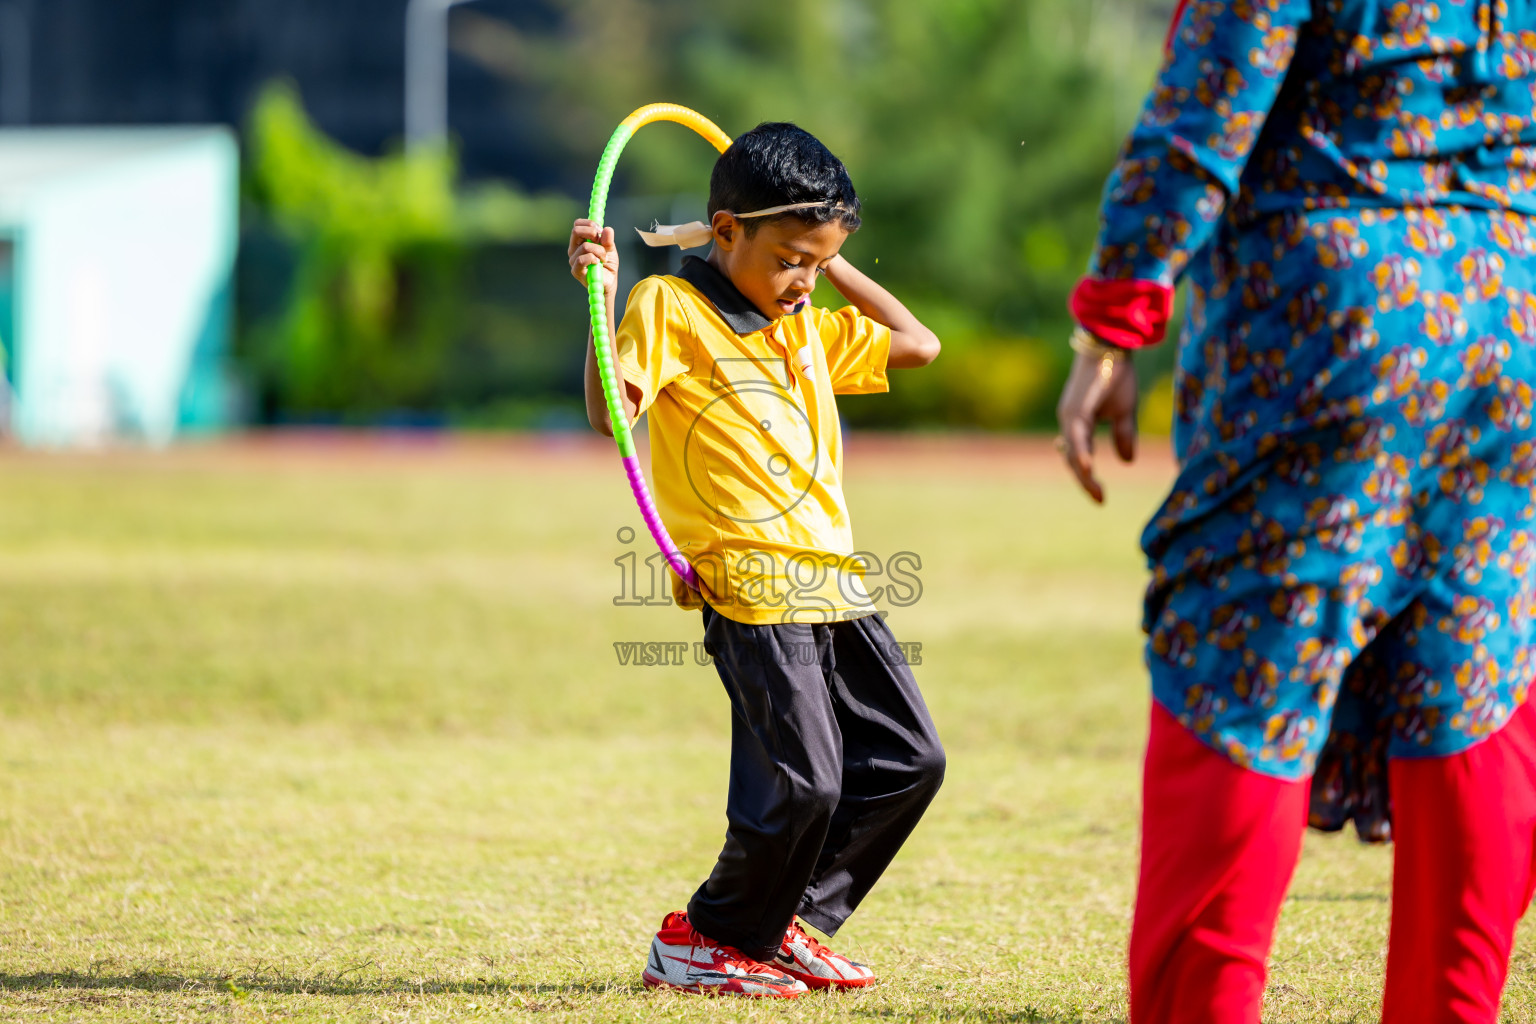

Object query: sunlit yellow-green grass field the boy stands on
[0,441,1536,1024]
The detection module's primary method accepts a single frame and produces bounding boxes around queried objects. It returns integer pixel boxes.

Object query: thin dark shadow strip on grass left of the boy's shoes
[0,963,645,996]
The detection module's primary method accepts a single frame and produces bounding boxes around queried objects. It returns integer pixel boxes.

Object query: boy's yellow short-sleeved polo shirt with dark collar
[617,256,891,625]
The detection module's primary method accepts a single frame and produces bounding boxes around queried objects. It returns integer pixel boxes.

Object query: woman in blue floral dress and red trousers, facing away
[1058,0,1536,1024]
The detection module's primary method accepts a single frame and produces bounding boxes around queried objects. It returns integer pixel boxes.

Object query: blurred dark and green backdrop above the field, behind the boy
[0,0,1174,430]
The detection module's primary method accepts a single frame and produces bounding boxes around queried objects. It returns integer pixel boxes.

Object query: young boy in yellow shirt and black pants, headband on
[570,124,945,996]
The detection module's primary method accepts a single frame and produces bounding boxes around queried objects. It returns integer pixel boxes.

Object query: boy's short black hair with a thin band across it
[710,121,860,236]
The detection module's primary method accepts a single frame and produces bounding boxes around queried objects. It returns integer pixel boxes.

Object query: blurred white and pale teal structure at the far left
[0,129,238,445]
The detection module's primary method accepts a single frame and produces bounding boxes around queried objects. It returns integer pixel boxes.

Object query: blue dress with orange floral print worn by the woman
[1091,0,1536,838]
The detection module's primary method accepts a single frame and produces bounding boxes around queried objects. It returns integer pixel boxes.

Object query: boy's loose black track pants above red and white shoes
[688,606,945,958]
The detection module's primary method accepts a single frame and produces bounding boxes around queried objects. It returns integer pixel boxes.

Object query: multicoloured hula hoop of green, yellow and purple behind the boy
[587,103,731,590]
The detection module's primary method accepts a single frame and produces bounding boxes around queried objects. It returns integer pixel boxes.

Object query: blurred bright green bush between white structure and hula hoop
[240,83,576,421]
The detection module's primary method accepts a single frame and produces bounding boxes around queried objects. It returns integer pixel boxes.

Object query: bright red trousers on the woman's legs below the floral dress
[1130,705,1536,1024]
